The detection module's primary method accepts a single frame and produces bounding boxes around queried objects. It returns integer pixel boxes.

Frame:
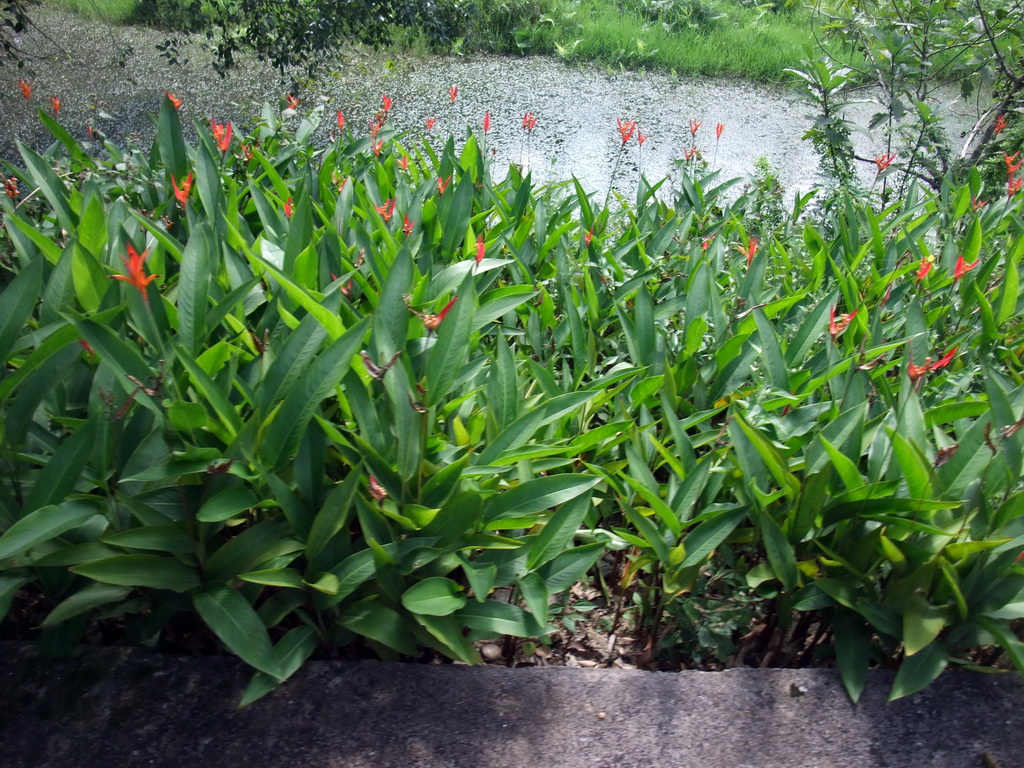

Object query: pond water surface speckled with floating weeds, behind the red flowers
[0,9,983,195]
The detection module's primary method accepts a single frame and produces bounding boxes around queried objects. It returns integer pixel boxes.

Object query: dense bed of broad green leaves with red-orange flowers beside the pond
[0,97,1024,701]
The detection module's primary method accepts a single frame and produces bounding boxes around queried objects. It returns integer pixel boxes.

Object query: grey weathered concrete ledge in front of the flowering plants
[0,643,1024,768]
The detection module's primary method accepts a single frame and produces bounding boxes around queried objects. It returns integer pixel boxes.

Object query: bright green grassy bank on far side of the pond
[51,0,812,80]
